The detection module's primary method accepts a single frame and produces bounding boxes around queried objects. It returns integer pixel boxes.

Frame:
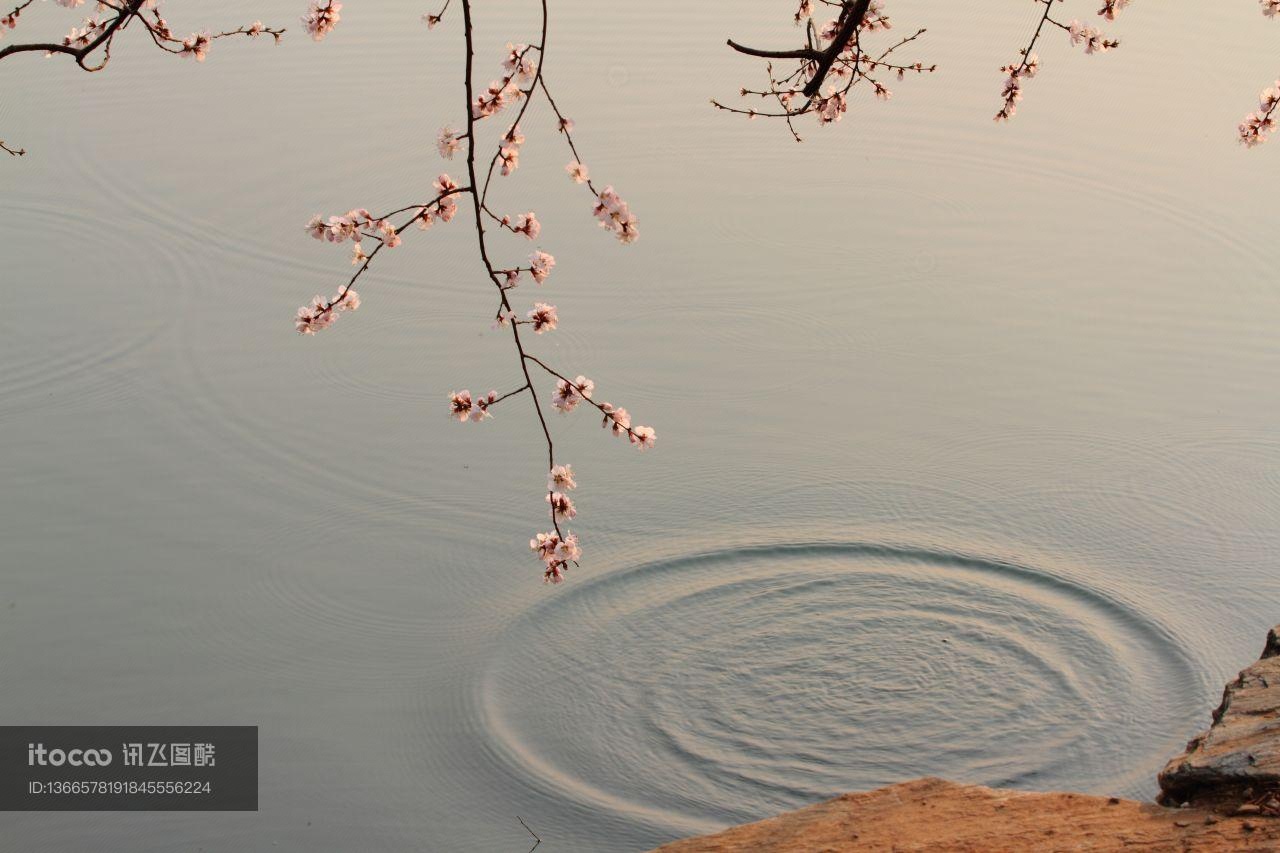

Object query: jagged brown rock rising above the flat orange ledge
[1160,628,1280,800]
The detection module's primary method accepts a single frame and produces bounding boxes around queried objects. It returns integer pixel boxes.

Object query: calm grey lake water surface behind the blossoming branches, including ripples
[0,0,1280,852]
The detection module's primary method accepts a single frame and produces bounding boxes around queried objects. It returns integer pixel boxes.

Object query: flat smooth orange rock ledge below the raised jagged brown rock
[658,779,1280,853]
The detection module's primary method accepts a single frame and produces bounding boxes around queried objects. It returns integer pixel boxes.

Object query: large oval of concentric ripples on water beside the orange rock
[481,543,1203,826]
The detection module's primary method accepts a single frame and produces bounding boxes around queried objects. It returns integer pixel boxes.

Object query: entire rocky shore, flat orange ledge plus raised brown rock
[658,626,1280,853]
